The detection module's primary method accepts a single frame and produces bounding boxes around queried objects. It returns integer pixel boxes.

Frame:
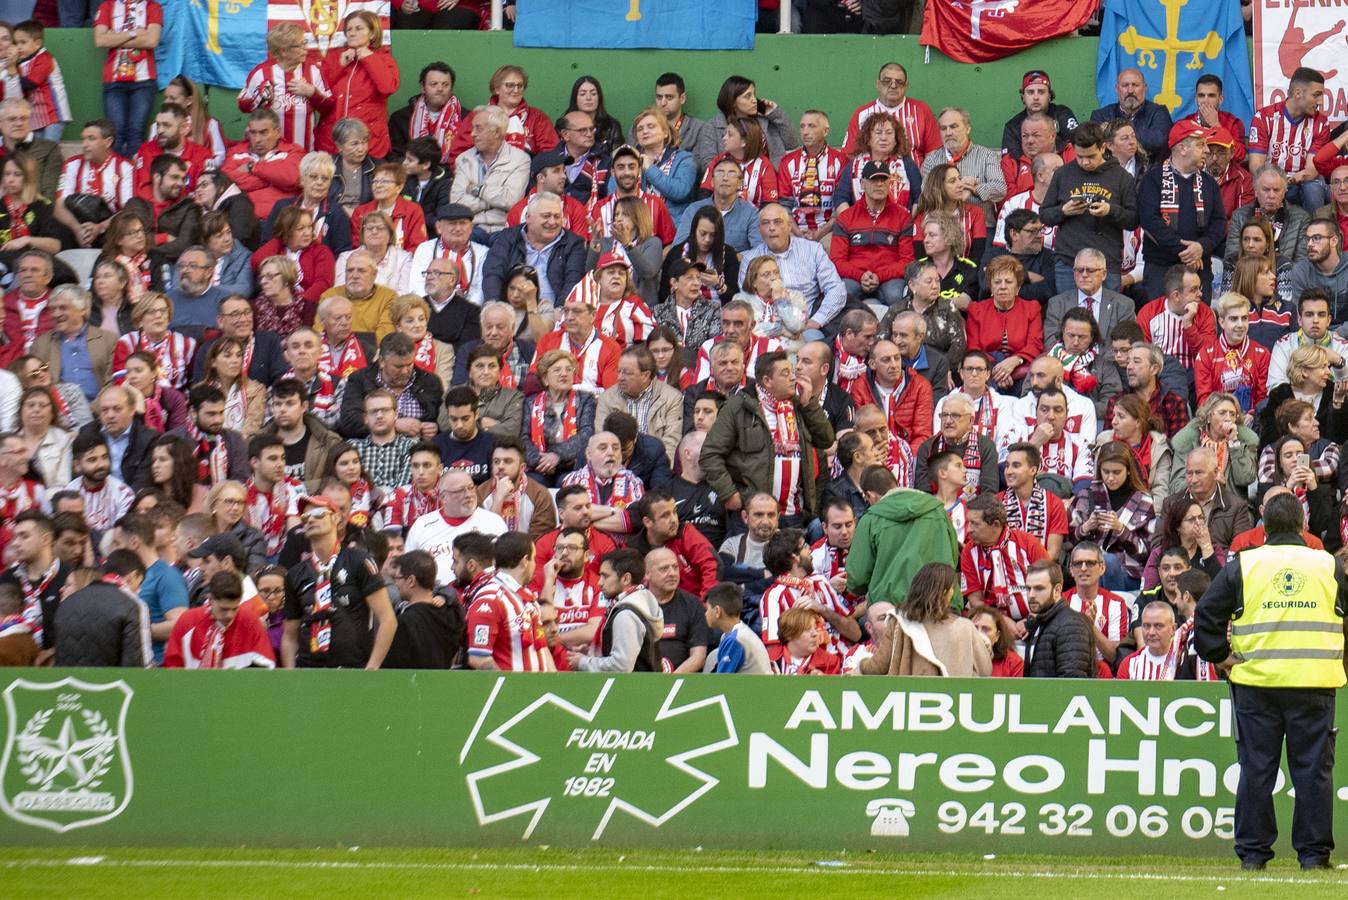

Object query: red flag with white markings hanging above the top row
[921,0,1100,62]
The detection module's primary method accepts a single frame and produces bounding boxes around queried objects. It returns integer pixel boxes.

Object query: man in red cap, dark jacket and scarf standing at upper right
[1138,121,1227,296]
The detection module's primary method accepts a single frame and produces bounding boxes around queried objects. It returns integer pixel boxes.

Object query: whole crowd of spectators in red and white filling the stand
[0,7,1348,680]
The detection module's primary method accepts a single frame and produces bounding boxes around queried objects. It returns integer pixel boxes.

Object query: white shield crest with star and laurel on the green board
[0,678,133,834]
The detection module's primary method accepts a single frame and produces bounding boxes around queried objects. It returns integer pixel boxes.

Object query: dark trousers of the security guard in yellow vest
[1231,683,1336,865]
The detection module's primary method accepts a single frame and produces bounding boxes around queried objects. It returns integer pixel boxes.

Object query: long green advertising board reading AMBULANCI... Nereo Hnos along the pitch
[0,670,1348,857]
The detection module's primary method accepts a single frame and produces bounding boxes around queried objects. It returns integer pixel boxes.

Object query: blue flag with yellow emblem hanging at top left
[158,0,267,88]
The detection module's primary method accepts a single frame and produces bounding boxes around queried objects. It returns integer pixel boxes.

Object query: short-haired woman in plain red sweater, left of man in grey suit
[968,256,1043,389]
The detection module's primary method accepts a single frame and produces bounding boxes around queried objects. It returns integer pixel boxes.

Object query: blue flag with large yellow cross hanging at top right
[1096,0,1254,123]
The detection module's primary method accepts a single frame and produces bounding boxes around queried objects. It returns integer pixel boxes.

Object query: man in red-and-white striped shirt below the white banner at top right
[1248,66,1329,212]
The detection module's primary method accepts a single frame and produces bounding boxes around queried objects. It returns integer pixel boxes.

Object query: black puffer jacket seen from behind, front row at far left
[57,582,154,668]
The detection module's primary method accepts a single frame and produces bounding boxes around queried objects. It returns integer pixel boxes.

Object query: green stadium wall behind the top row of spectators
[47,28,1099,147]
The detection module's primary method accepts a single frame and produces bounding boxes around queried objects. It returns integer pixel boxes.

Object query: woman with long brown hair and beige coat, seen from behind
[860,562,992,678]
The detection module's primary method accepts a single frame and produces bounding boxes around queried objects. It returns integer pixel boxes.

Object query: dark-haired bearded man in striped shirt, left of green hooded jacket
[759,528,861,656]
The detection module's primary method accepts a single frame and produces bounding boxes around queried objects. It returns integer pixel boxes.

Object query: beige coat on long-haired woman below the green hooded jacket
[860,610,992,678]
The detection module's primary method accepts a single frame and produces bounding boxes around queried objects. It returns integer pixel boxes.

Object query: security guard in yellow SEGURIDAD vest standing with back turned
[1194,494,1348,869]
